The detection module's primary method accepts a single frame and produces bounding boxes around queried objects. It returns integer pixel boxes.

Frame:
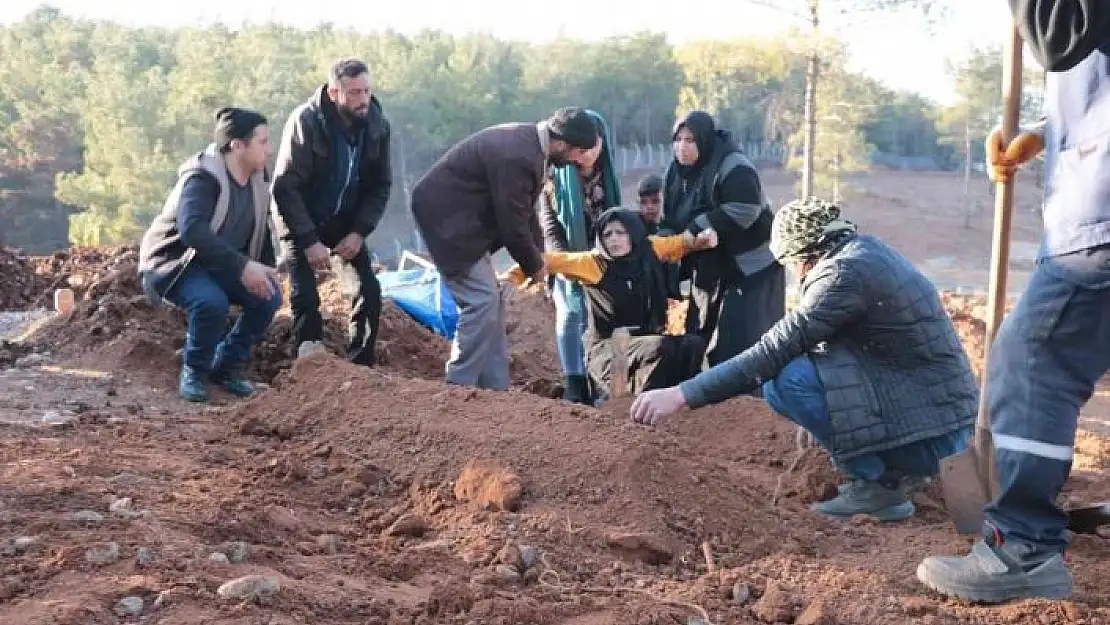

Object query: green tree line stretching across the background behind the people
[0,7,1021,252]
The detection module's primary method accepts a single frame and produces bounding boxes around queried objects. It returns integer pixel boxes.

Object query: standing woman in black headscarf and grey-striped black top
[663,111,786,366]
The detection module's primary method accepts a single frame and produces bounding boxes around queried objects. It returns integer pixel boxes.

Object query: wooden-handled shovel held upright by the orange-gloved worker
[940,27,1021,534]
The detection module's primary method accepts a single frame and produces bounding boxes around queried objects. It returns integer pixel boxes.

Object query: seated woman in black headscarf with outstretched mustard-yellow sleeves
[505,208,717,395]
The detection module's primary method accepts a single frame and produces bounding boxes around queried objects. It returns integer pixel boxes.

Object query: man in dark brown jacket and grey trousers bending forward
[412,107,598,391]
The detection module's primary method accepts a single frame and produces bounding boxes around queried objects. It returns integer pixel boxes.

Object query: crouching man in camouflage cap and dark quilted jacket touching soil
[632,198,978,521]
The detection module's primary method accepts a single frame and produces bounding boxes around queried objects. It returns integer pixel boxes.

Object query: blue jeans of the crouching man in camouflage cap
[763,355,971,482]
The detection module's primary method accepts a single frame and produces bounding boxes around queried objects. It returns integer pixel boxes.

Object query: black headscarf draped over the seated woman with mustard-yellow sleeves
[594,208,667,333]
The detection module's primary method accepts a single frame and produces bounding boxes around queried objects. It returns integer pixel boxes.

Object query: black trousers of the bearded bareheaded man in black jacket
[289,222,382,366]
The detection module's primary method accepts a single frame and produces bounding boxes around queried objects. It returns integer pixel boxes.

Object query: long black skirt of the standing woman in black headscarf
[686,256,786,367]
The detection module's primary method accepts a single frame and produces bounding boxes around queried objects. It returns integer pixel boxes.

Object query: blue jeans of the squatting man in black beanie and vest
[165,262,281,373]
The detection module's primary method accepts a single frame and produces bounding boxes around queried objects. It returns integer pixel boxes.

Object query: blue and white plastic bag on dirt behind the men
[377,268,458,339]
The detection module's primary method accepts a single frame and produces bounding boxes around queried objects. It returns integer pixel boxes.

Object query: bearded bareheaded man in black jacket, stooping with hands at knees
[273,59,393,366]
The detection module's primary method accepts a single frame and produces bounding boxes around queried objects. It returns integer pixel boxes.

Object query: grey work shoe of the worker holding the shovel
[917,532,1072,603]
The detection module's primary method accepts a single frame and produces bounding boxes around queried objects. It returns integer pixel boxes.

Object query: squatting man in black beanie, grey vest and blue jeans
[139,107,281,402]
